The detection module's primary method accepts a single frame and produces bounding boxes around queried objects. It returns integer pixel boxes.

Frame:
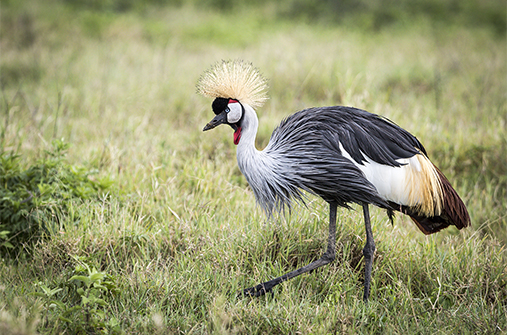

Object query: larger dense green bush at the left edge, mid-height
[0,140,112,252]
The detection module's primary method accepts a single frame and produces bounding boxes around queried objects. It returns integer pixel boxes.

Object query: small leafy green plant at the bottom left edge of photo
[33,262,121,334]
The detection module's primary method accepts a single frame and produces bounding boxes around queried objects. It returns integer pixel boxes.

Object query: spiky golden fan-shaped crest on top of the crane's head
[197,60,268,108]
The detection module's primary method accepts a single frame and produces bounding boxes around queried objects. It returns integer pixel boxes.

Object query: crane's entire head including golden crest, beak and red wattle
[197,60,267,145]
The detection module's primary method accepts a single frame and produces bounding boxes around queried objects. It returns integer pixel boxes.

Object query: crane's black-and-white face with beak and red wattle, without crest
[203,98,245,145]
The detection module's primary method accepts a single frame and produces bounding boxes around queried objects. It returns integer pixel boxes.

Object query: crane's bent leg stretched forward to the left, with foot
[240,203,337,297]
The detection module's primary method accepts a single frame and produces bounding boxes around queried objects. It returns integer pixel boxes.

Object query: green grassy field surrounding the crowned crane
[0,0,507,334]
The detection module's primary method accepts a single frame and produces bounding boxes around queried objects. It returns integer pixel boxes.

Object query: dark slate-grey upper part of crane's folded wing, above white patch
[276,106,426,166]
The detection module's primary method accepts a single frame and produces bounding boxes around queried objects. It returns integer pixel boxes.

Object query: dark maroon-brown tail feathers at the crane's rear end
[392,167,470,235]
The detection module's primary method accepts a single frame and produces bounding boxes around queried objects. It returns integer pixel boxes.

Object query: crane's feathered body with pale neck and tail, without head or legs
[237,106,468,234]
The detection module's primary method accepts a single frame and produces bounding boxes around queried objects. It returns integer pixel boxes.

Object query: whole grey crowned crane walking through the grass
[196,59,470,303]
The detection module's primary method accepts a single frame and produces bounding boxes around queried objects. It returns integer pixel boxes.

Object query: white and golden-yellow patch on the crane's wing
[340,143,443,216]
